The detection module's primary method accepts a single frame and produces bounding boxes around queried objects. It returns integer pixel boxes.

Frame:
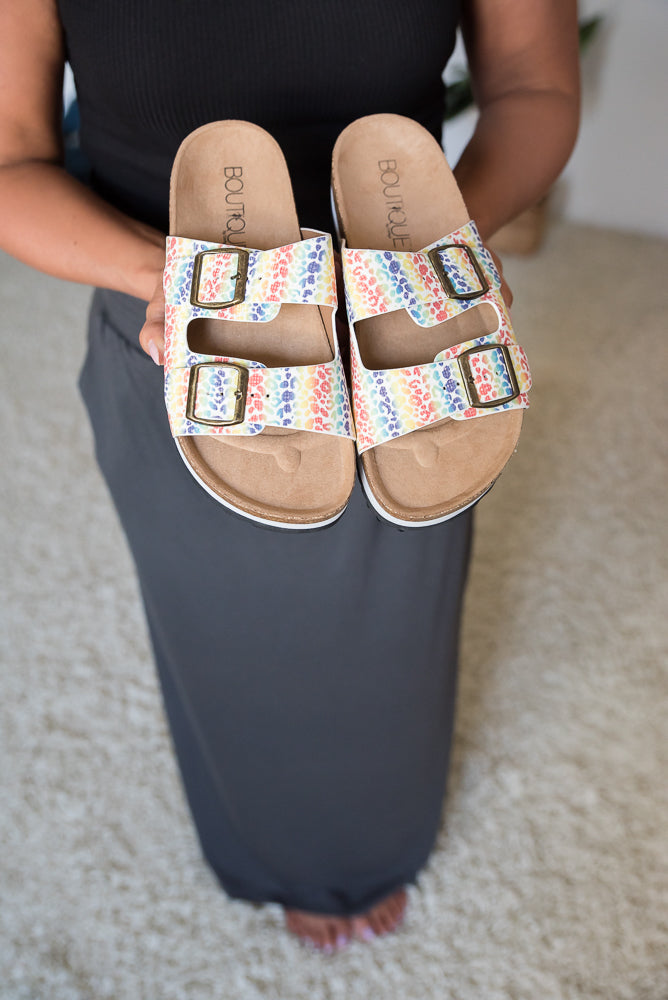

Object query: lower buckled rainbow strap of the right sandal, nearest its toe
[353,331,531,454]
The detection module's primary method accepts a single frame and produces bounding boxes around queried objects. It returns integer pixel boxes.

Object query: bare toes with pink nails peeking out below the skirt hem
[285,889,406,954]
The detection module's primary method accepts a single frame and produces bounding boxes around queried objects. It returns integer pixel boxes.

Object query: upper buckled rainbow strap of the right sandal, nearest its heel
[341,221,501,327]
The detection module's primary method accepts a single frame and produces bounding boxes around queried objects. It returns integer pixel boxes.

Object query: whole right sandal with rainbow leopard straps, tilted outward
[332,114,531,527]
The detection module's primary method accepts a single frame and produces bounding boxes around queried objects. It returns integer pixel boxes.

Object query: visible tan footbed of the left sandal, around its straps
[169,121,355,527]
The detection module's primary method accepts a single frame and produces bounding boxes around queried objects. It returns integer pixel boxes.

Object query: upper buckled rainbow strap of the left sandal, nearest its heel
[163,233,337,323]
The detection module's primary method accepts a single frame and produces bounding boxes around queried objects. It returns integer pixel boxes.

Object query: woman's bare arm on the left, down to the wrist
[0,0,165,316]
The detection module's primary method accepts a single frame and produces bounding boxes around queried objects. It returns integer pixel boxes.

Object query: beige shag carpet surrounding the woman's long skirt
[0,225,668,1000]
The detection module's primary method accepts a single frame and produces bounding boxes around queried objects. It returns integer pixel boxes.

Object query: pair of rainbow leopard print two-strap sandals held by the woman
[164,114,531,530]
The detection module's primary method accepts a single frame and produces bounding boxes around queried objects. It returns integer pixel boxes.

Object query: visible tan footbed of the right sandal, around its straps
[332,115,522,525]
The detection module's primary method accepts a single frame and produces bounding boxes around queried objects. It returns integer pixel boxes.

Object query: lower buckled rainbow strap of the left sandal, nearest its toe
[165,356,355,440]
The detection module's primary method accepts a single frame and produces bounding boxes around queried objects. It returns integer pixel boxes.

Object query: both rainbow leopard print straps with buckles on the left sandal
[164,233,355,440]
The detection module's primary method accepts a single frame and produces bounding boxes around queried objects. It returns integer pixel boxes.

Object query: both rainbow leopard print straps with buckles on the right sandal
[342,222,531,453]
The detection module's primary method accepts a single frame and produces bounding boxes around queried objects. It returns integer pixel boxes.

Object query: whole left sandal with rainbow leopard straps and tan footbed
[164,121,355,530]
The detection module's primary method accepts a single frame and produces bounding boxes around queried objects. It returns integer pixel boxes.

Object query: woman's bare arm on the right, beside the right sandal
[455,0,580,239]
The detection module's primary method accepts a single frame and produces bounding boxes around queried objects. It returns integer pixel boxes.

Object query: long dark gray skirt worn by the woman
[81,291,471,914]
